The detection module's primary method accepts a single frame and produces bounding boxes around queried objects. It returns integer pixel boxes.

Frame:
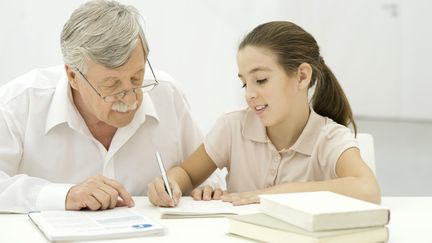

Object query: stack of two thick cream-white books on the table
[228,191,390,243]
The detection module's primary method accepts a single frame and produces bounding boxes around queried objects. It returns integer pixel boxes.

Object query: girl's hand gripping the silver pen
[147,177,182,207]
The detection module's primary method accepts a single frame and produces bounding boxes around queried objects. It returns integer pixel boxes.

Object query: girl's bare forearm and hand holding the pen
[147,144,217,207]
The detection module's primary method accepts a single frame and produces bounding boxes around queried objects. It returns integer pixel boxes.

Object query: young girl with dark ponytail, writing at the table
[148,21,380,206]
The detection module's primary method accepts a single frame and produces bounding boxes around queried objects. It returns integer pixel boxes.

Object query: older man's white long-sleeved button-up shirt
[0,66,224,212]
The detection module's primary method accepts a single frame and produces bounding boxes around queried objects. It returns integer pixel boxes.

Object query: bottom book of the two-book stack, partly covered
[227,213,388,243]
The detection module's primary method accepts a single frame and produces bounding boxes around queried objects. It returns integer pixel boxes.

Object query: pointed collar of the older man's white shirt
[45,73,159,134]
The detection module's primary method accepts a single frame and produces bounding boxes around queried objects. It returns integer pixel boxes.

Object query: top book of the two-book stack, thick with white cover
[259,191,390,231]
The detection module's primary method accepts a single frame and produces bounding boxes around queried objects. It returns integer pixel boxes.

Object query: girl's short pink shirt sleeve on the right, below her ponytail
[319,122,359,178]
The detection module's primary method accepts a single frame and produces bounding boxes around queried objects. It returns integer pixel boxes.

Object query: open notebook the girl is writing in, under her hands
[159,197,259,219]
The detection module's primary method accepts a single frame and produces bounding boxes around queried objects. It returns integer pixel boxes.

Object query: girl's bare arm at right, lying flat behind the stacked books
[222,148,381,205]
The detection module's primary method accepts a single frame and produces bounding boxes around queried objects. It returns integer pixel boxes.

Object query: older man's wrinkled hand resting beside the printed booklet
[65,175,135,210]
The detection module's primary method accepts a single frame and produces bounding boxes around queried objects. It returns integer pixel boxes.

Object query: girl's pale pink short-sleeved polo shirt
[204,108,358,192]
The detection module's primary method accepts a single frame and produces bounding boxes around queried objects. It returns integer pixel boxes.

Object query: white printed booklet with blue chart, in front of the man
[29,207,165,241]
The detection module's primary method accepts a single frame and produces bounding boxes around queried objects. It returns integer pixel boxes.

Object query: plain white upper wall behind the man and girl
[0,0,432,194]
